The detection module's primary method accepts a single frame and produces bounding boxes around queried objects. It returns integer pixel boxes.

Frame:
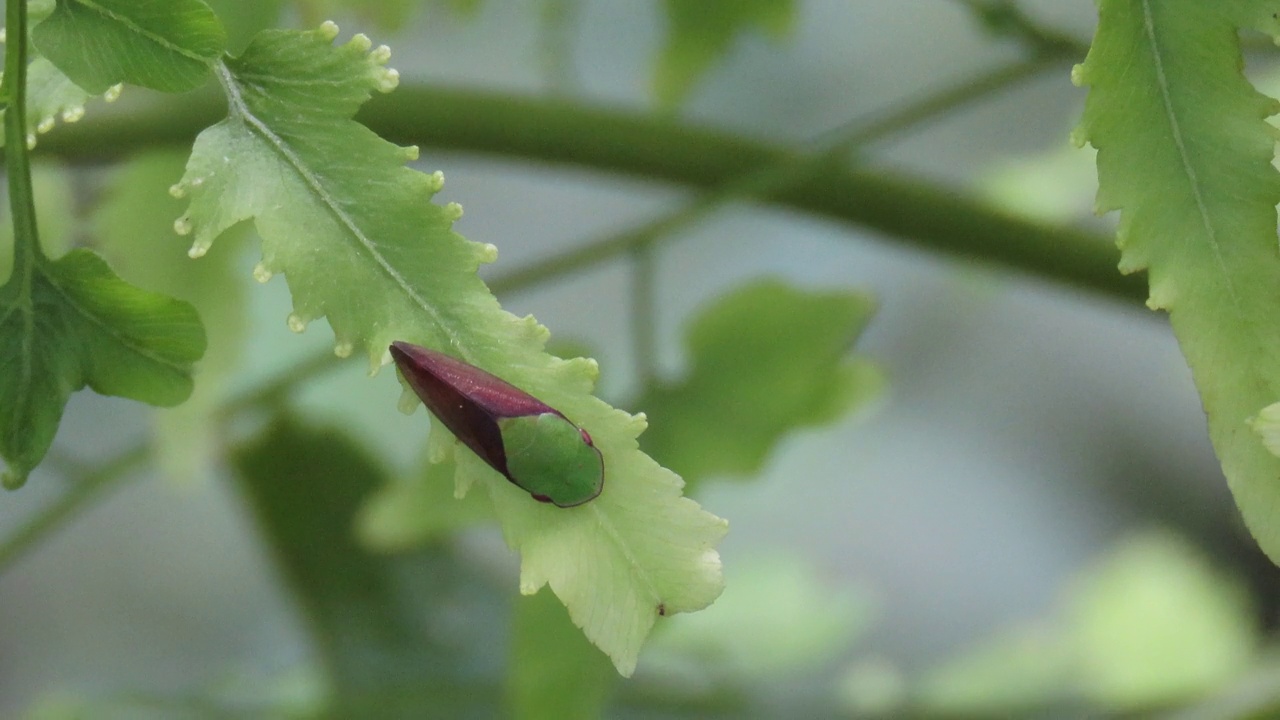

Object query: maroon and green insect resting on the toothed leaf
[390,342,604,507]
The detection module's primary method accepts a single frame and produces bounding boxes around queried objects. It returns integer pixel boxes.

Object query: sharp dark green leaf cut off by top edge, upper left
[31,0,227,94]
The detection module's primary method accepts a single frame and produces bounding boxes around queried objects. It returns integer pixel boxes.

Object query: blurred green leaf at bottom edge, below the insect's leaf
[507,589,617,720]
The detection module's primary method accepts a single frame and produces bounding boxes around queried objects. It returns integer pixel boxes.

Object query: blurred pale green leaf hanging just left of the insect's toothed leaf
[93,151,248,478]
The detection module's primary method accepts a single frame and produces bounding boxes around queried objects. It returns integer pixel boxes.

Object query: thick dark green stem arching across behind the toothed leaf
[41,86,1147,301]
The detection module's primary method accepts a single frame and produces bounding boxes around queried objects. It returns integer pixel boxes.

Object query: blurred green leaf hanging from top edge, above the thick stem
[653,0,795,108]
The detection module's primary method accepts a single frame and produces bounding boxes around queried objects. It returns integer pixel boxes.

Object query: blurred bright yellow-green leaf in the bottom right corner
[916,532,1257,716]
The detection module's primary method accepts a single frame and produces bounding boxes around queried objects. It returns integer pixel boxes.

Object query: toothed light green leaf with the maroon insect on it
[174,23,726,674]
